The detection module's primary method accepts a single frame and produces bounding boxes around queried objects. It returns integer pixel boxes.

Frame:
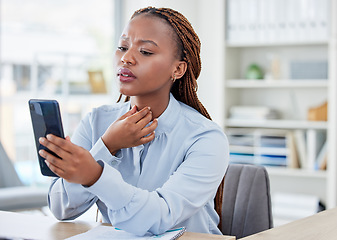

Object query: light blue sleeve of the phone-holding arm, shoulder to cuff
[87,128,229,235]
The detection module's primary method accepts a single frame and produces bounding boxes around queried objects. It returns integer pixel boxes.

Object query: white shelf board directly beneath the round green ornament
[226,79,328,88]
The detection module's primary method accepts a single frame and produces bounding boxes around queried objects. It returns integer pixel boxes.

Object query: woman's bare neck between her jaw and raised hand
[131,94,170,119]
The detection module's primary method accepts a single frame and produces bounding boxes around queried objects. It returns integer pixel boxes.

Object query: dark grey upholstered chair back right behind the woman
[220,164,273,239]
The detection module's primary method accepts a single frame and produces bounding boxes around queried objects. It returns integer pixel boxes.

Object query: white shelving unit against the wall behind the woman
[223,0,337,208]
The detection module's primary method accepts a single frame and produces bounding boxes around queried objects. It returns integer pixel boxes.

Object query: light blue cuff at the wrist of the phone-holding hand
[86,160,135,211]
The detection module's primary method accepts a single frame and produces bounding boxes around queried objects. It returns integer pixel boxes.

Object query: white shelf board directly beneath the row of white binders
[226,40,329,48]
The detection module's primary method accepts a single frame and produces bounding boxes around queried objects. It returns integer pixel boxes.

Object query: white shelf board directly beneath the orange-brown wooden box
[226,119,328,130]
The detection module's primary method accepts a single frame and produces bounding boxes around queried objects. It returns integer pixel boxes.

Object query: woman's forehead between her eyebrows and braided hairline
[122,15,174,46]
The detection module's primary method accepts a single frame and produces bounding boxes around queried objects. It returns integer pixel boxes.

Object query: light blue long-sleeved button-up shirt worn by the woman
[49,94,229,235]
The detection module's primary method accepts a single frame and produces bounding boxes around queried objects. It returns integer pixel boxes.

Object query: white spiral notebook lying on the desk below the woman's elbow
[67,225,185,240]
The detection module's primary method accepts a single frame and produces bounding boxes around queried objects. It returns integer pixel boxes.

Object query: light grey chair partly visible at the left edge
[0,142,48,211]
